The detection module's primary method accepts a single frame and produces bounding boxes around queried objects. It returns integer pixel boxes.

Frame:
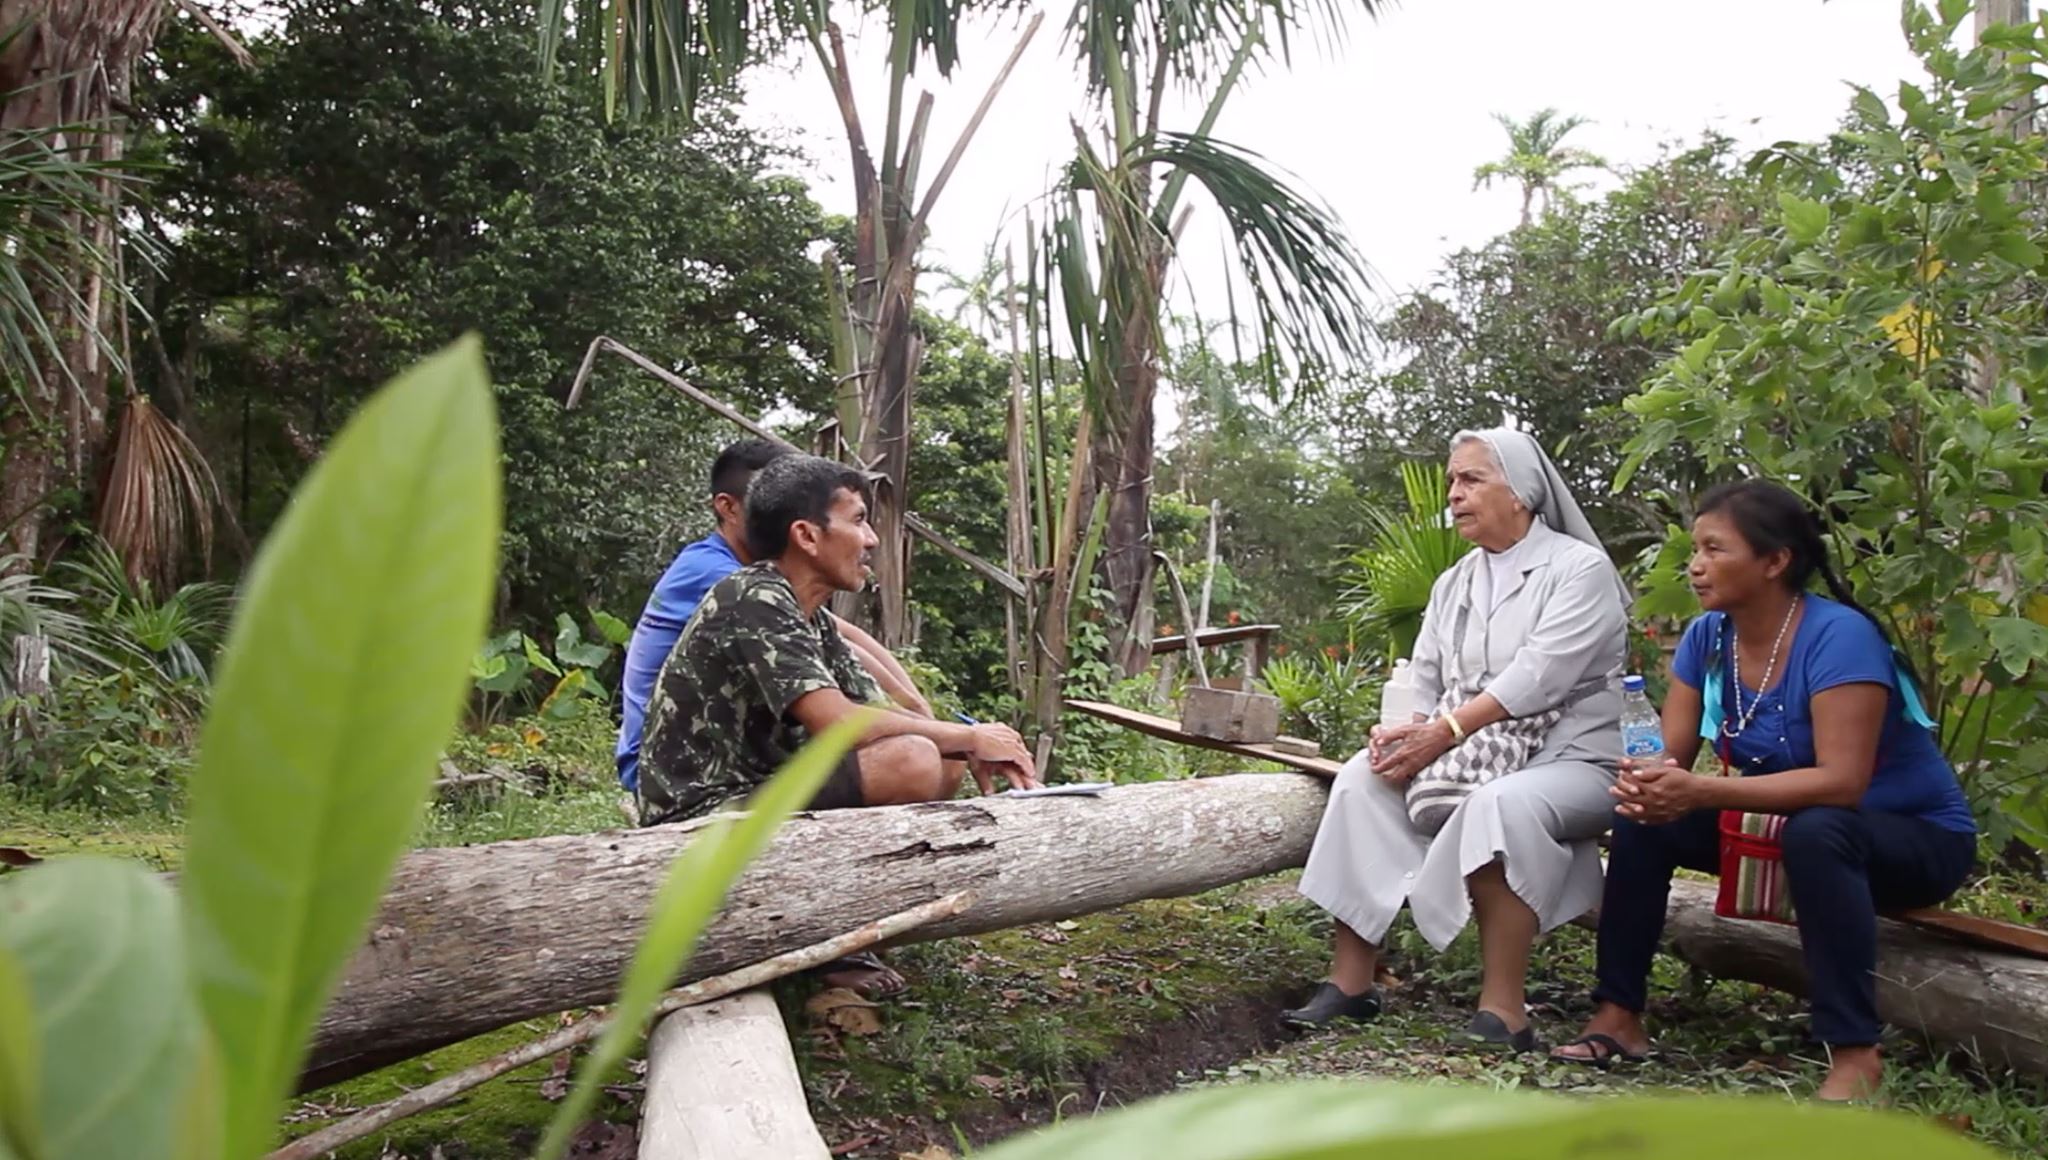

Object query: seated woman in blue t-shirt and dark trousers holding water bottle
[1554,482,1976,1101]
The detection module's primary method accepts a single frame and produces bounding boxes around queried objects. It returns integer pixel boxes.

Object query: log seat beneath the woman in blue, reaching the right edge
[1665,881,2048,1074]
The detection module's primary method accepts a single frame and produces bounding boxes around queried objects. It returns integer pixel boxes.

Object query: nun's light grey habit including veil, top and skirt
[1300,432,1628,949]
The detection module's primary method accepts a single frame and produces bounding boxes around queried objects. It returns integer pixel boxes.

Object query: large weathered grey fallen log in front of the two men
[303,775,1325,1086]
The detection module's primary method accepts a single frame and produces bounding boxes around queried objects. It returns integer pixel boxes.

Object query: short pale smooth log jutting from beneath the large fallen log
[639,990,831,1160]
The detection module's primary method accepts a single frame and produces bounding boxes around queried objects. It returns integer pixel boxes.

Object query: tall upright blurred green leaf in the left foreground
[180,336,500,1158]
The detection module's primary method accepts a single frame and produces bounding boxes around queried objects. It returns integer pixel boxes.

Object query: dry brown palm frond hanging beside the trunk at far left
[98,393,221,588]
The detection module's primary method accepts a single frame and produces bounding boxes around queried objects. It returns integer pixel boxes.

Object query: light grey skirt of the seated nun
[1300,750,1614,951]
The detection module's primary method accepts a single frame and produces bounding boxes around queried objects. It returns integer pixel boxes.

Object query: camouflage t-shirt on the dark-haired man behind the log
[639,562,883,826]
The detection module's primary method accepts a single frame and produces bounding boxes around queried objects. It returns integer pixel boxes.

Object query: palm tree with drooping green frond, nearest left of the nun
[1034,0,1378,672]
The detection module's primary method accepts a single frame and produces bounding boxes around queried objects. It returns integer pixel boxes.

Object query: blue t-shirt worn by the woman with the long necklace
[1671,594,1976,834]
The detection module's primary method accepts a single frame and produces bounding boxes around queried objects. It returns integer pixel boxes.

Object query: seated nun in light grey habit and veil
[1284,428,1628,1049]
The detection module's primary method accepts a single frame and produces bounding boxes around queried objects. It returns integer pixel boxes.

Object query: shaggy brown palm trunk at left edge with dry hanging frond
[0,10,248,582]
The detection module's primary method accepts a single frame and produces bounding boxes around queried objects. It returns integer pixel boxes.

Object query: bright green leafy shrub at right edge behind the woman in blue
[1616,4,2048,844]
